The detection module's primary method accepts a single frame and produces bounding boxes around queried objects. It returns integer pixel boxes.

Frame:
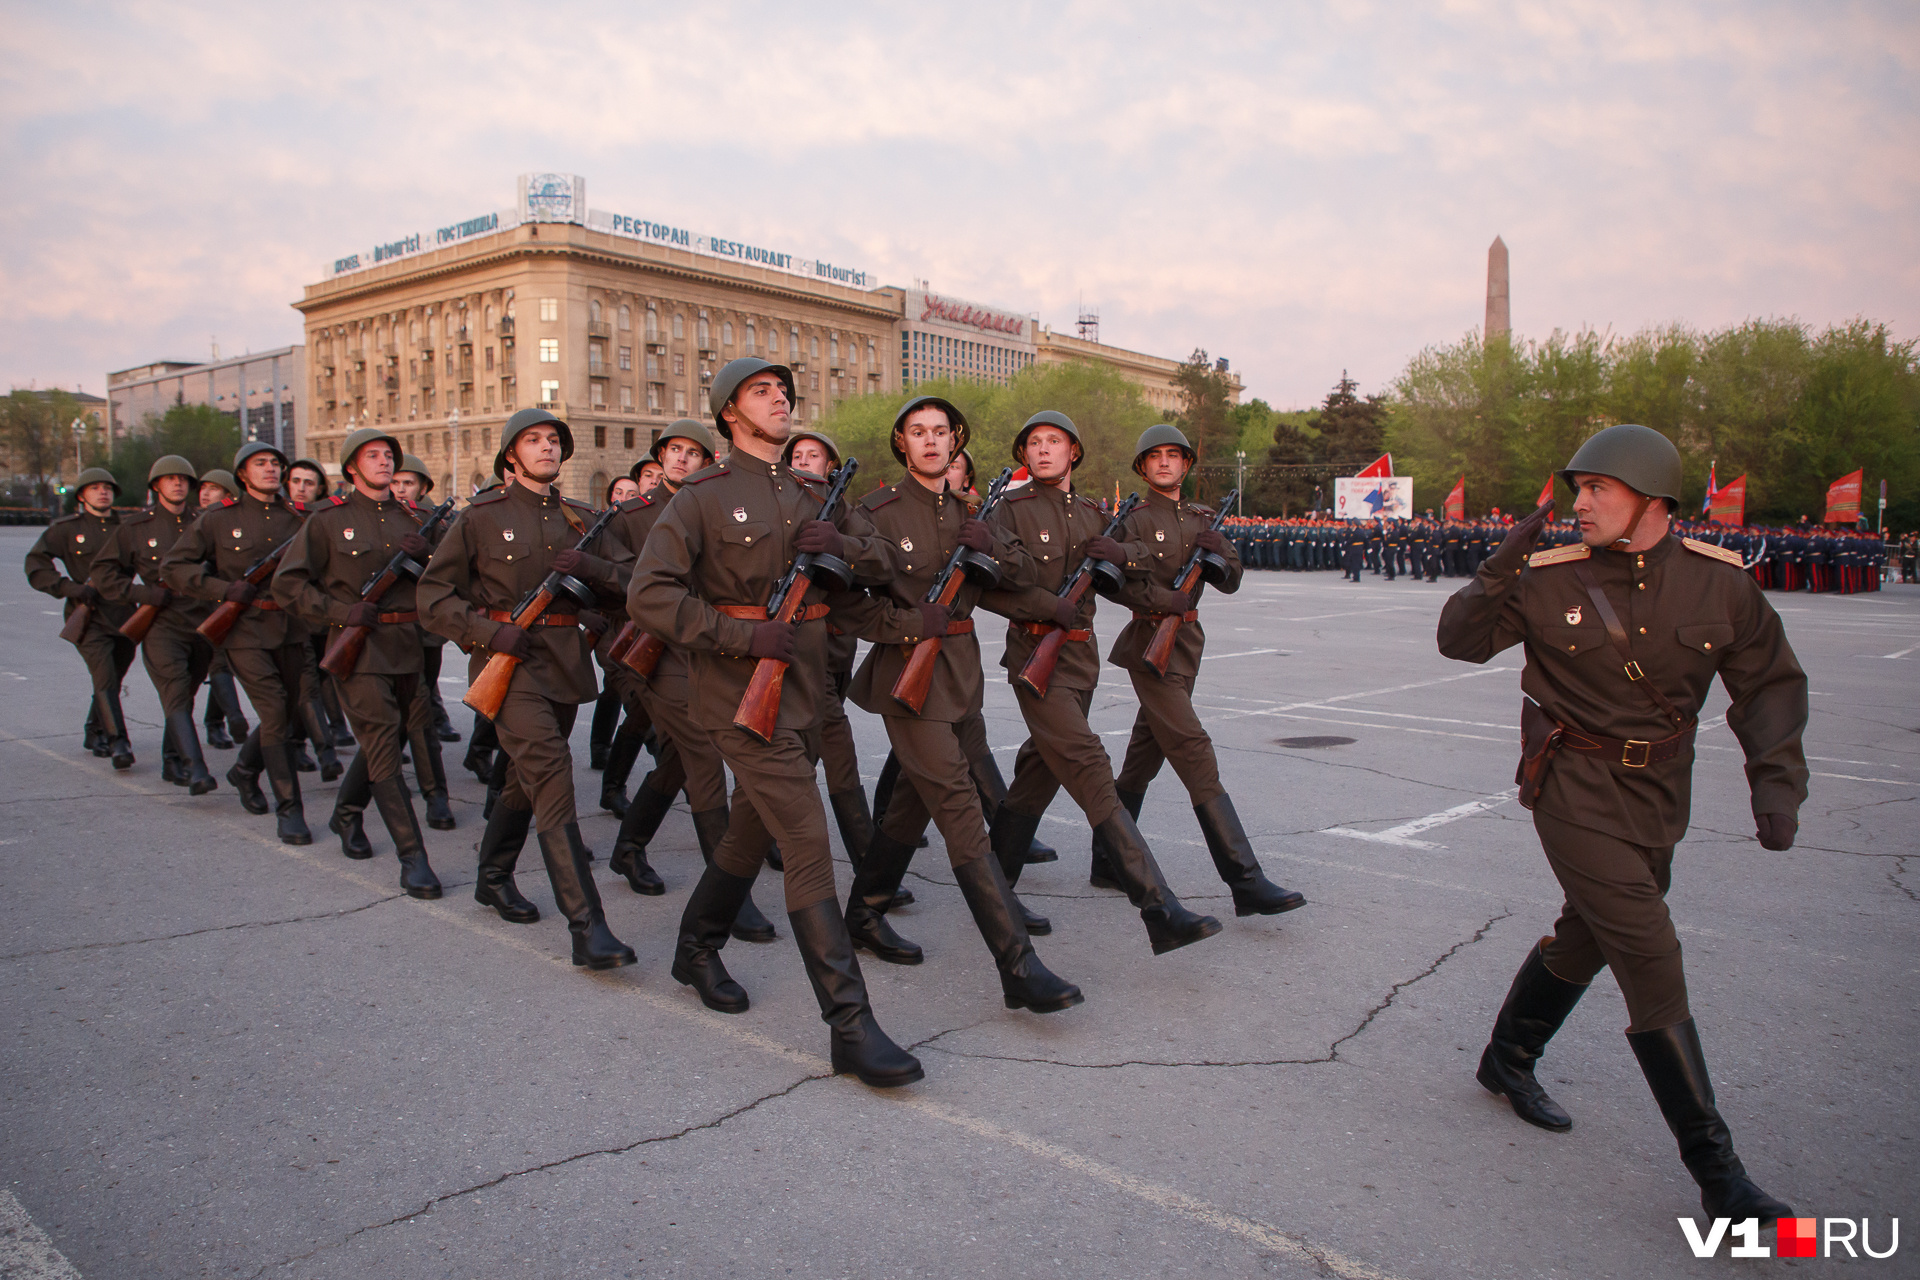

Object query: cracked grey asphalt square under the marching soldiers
[0,530,1920,1280]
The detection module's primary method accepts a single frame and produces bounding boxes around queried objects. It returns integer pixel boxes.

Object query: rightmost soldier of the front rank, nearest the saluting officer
[1091,424,1306,915]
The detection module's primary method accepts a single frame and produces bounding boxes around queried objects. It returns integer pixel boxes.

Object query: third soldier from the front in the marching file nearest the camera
[273,426,440,898]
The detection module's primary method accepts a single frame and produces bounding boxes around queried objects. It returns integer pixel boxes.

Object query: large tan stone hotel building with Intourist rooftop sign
[296,175,900,503]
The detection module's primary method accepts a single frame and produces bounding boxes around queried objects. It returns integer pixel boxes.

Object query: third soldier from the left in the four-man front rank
[981,409,1219,956]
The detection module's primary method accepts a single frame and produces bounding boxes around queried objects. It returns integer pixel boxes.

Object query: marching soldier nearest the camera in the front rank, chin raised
[628,357,924,1088]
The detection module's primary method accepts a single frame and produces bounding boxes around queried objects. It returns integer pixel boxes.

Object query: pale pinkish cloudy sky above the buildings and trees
[0,0,1920,407]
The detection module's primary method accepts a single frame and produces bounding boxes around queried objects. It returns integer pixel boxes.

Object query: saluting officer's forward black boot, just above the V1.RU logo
[1626,1017,1793,1226]
